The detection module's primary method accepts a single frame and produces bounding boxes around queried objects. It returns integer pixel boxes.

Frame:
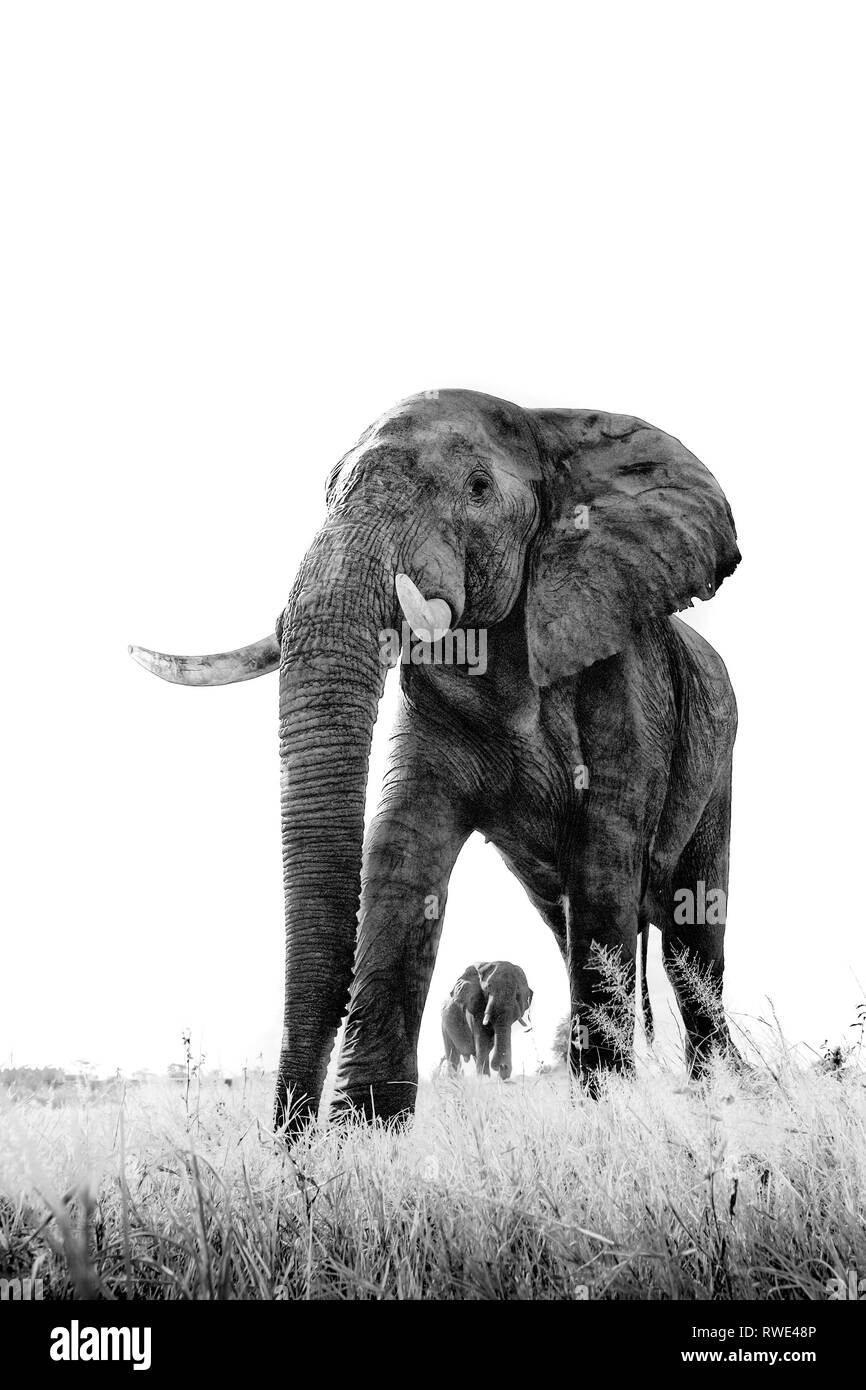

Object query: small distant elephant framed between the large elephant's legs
[442,960,532,1081]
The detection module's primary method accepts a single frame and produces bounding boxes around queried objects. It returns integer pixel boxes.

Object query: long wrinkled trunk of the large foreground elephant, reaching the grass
[275,521,396,1129]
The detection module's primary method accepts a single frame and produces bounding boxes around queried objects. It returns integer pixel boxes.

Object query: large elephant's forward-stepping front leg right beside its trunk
[335,763,468,1119]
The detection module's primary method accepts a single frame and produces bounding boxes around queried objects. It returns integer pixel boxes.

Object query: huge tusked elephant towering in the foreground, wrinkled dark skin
[131,391,740,1125]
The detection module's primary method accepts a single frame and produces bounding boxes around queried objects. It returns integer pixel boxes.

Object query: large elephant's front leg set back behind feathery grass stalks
[566,841,641,1090]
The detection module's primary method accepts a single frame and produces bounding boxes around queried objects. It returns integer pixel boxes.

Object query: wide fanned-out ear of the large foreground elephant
[527,410,740,685]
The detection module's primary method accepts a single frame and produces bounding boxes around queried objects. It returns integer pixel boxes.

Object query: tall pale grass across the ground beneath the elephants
[0,1023,866,1300]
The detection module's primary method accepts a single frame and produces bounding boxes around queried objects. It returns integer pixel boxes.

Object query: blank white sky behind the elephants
[0,0,866,1070]
